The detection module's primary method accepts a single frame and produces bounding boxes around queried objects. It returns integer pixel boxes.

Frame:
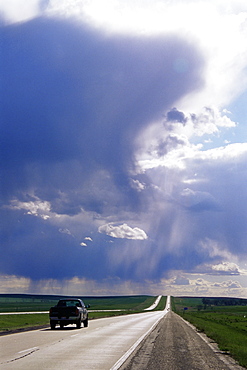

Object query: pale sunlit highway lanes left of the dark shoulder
[0,297,170,370]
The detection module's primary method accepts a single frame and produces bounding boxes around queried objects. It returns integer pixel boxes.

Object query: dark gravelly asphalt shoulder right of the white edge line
[120,312,243,370]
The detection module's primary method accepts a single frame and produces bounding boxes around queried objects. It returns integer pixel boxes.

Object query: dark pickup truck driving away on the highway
[49,298,89,330]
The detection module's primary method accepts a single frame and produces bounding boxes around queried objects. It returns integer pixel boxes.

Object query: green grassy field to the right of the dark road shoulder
[172,297,247,368]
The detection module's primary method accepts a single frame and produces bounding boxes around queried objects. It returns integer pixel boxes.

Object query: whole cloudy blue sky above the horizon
[0,0,247,298]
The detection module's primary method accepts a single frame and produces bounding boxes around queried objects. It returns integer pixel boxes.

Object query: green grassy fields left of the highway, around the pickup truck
[0,294,166,334]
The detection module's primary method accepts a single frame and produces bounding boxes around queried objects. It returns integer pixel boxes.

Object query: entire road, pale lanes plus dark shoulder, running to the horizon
[0,296,242,370]
